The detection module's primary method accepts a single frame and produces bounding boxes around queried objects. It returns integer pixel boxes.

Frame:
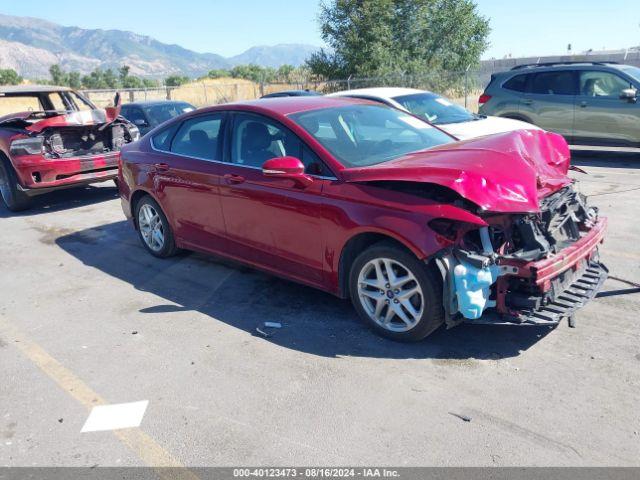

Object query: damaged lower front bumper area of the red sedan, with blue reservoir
[437,218,608,327]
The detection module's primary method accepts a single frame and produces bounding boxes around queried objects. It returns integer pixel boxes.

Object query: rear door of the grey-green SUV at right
[520,70,578,141]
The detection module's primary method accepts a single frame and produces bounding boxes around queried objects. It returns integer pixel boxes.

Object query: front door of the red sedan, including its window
[220,113,327,285]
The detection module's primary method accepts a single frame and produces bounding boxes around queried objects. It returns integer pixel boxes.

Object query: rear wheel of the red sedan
[135,196,178,258]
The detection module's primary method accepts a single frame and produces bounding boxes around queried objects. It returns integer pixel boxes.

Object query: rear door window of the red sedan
[171,114,222,160]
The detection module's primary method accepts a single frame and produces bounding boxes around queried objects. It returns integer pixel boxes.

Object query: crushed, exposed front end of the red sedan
[437,184,607,326]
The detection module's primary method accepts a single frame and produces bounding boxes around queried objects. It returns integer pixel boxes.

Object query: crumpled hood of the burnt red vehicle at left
[0,106,121,133]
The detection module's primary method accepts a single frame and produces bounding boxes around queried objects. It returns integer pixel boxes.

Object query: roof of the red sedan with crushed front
[209,96,372,115]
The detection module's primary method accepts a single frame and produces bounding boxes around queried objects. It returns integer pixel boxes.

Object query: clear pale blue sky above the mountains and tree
[0,0,640,58]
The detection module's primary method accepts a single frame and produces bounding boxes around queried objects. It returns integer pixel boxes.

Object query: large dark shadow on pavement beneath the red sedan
[55,221,551,360]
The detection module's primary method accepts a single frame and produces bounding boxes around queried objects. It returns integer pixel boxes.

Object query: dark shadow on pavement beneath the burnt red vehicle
[0,182,118,218]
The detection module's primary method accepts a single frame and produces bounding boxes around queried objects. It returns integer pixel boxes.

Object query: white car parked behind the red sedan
[329,87,537,140]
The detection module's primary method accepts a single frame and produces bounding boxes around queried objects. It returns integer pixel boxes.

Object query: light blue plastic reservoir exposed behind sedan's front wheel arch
[453,262,500,320]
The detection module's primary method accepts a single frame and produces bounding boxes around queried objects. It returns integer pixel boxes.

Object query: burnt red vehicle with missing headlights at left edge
[0,85,140,211]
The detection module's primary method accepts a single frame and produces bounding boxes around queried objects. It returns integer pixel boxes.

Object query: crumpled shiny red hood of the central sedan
[342,130,572,213]
